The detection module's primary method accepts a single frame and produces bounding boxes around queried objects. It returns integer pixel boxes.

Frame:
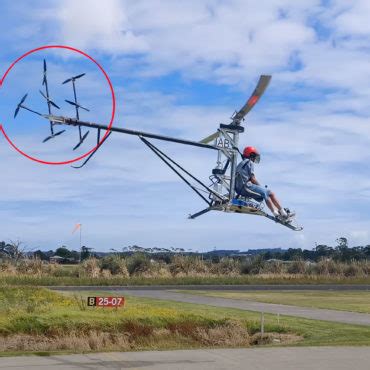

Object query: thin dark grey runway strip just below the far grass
[49,284,370,291]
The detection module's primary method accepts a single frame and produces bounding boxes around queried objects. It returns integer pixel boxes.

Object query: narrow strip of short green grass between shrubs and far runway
[0,274,370,286]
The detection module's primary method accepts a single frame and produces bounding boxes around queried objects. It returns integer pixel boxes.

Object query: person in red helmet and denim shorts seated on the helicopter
[235,146,295,222]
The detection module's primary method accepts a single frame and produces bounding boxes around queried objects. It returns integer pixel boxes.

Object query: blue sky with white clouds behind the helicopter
[0,0,370,251]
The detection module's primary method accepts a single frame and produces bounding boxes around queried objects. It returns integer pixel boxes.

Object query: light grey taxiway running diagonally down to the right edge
[108,290,370,326]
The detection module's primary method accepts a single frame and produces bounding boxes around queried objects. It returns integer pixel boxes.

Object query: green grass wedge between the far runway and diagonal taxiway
[176,290,370,313]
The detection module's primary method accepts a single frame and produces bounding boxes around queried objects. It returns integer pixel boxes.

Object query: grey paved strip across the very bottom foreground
[0,347,370,370]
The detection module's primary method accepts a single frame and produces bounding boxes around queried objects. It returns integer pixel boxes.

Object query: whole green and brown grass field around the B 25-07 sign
[0,287,370,354]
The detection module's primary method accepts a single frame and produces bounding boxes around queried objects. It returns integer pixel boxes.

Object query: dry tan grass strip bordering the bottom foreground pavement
[0,321,303,352]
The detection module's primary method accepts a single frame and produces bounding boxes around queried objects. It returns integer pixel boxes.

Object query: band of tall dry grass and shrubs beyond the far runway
[0,253,370,285]
